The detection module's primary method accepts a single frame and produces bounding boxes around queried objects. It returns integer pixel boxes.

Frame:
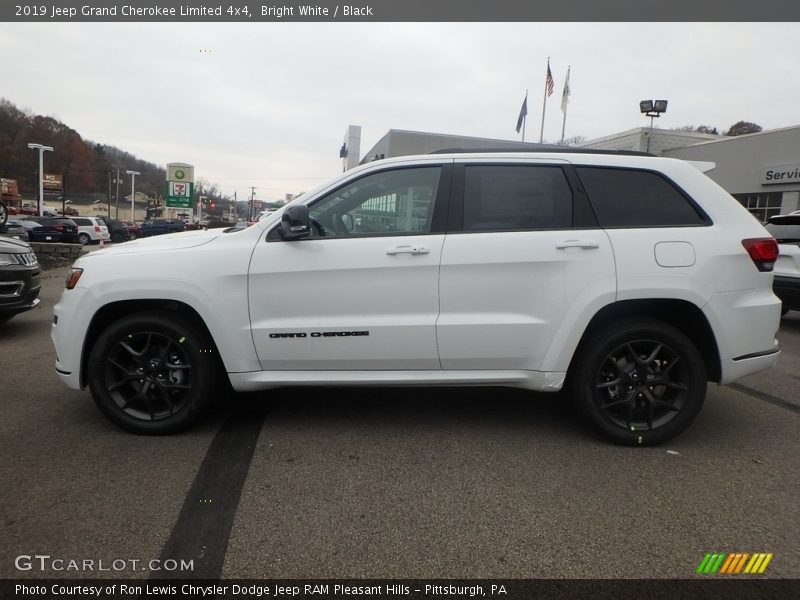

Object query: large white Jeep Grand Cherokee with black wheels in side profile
[52,151,780,445]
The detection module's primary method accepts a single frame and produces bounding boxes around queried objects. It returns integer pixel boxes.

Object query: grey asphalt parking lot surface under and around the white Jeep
[0,267,800,578]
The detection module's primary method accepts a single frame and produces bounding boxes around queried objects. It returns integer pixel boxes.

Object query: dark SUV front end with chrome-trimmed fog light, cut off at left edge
[0,237,41,325]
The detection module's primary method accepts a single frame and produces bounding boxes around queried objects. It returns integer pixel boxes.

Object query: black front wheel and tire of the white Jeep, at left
[88,311,220,435]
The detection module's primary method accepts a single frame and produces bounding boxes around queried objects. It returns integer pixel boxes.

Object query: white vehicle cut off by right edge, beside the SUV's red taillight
[767,211,800,315]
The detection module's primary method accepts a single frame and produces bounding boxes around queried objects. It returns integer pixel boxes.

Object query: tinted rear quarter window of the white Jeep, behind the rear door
[576,167,710,228]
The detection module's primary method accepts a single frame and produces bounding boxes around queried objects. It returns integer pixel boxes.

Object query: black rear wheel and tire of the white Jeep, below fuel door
[570,318,706,446]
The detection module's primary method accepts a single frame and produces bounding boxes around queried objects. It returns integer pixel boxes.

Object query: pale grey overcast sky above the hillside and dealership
[0,23,800,199]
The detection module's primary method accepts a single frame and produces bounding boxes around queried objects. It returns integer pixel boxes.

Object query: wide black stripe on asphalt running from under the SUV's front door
[151,401,268,579]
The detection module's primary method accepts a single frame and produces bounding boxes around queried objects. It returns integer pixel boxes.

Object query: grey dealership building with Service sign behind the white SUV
[350,125,800,221]
